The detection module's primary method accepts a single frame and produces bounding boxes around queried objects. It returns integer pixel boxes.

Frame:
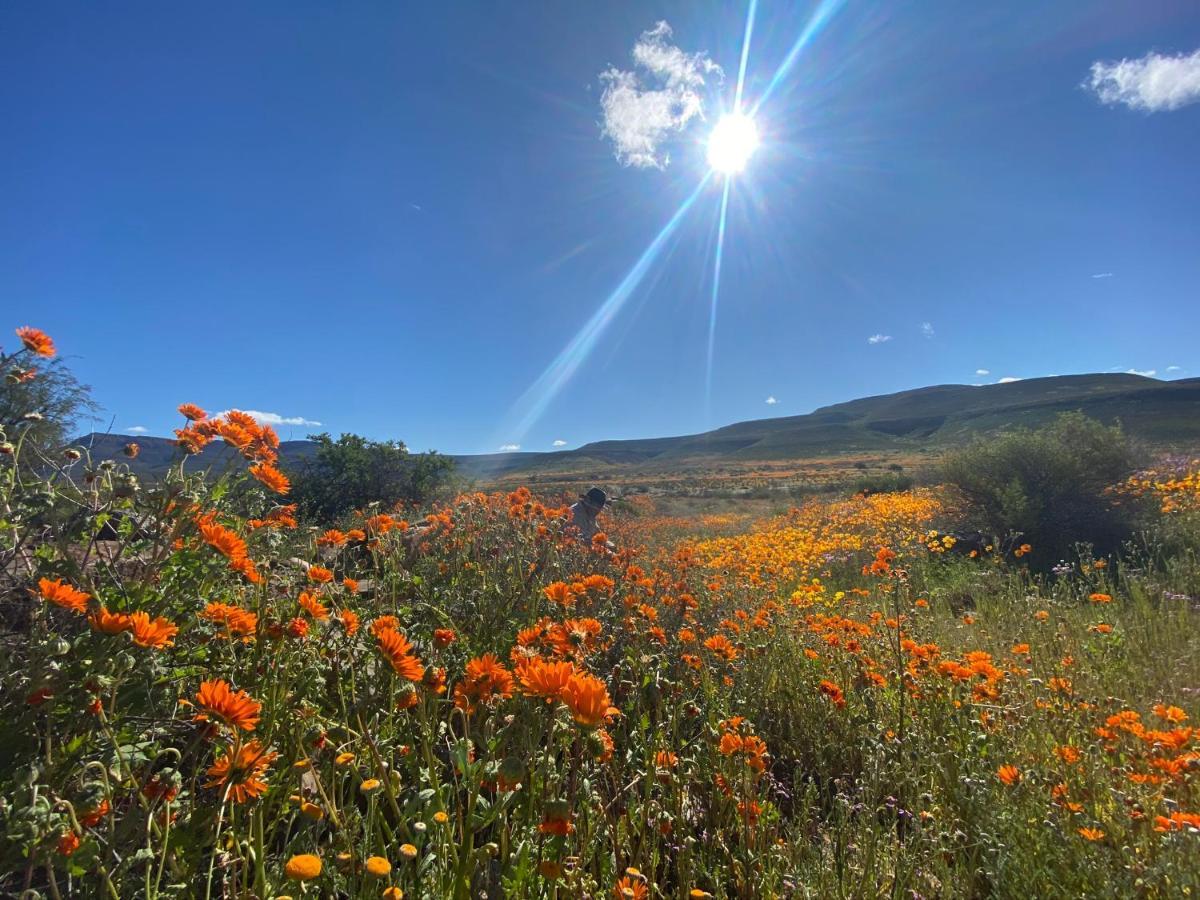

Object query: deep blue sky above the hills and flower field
[0,0,1200,452]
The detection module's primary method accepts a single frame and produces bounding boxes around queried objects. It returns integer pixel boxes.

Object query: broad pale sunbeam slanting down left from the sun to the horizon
[506,173,712,440]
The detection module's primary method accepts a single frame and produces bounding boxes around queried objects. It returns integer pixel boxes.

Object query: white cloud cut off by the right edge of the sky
[1084,50,1200,113]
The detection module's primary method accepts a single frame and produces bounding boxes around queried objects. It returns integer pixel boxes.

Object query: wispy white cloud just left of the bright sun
[600,22,724,169]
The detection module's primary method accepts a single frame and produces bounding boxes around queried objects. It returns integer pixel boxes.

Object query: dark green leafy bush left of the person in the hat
[290,433,454,522]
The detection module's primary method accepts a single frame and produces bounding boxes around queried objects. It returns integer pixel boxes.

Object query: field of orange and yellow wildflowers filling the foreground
[0,330,1200,899]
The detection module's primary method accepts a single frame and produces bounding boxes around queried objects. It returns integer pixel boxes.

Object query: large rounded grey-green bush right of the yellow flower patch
[942,413,1134,565]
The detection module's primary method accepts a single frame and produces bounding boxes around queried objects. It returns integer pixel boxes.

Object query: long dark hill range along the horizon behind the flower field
[80,374,1200,481]
